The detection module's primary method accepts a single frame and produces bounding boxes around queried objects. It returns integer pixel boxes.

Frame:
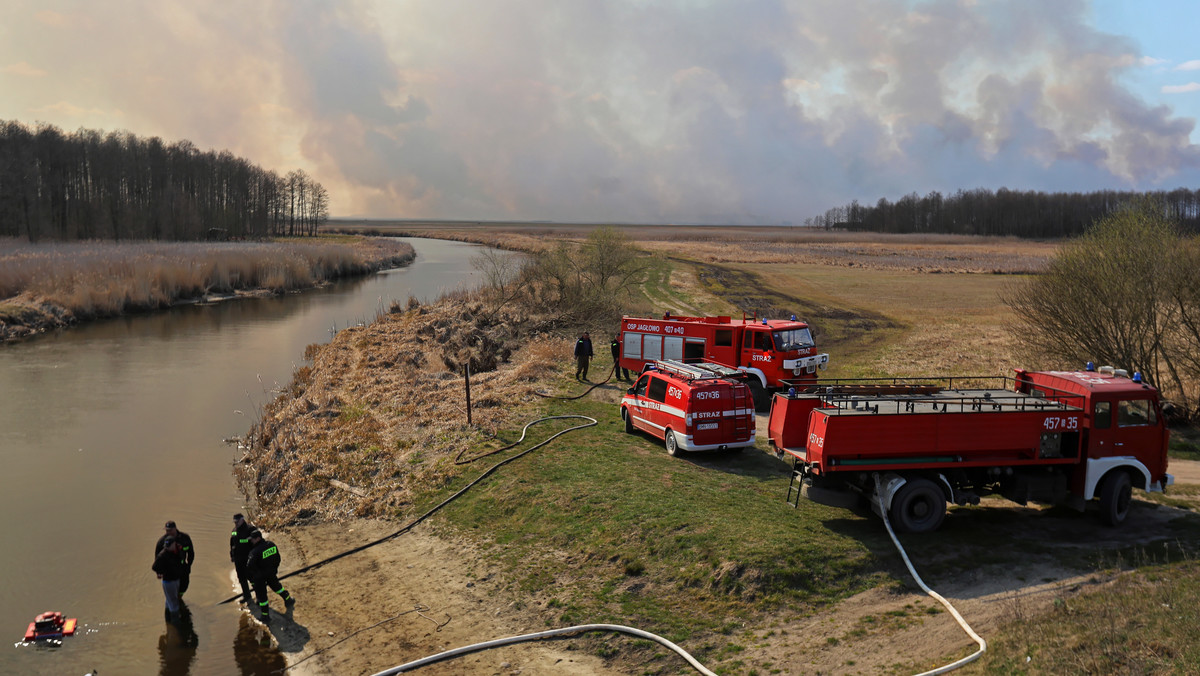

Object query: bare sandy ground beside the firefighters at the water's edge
[254,521,623,676]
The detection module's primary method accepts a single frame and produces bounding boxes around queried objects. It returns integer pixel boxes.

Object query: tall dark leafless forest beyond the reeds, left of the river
[0,120,329,241]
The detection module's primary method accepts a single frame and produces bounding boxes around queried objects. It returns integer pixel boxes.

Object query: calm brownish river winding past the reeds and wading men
[0,239,492,675]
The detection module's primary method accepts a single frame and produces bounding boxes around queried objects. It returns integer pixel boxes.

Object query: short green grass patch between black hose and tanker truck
[403,372,887,672]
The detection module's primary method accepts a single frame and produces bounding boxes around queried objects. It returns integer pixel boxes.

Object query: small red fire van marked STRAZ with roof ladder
[620,359,755,455]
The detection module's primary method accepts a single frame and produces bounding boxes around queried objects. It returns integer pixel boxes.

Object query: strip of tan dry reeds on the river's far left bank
[0,237,415,342]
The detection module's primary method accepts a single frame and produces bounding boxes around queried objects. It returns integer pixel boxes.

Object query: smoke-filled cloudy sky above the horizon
[0,0,1200,225]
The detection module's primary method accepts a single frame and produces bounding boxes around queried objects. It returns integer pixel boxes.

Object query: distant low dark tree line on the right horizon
[804,187,1200,239]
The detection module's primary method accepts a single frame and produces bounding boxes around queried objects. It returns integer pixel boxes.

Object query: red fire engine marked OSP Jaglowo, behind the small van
[619,313,829,409]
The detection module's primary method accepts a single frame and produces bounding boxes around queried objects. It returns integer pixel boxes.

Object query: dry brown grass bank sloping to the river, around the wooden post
[242,298,571,524]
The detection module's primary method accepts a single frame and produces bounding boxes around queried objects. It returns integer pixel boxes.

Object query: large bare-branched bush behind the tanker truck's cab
[1004,199,1200,411]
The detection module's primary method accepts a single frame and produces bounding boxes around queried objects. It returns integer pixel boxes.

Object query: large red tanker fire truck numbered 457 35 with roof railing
[768,365,1174,532]
